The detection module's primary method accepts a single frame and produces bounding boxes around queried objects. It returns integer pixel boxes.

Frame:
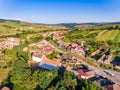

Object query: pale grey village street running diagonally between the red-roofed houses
[44,40,120,85]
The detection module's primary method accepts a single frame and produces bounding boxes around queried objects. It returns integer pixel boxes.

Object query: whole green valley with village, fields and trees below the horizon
[0,21,120,90]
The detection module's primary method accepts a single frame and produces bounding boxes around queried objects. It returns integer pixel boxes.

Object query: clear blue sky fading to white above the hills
[0,0,120,24]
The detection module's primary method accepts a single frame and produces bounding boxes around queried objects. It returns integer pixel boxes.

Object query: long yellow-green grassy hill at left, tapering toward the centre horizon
[0,19,67,36]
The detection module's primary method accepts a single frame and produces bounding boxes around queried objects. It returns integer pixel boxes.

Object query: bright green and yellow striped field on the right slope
[96,30,120,42]
